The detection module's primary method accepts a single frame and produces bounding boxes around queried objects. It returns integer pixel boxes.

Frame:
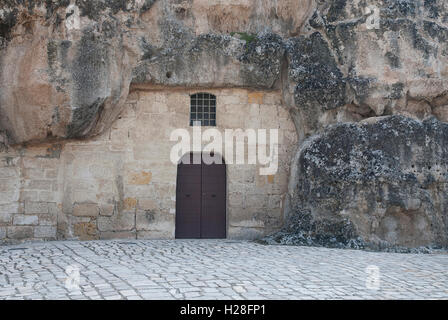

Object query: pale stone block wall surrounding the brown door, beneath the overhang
[0,88,297,241]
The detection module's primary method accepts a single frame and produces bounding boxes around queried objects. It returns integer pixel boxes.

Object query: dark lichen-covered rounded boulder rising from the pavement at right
[268,116,448,248]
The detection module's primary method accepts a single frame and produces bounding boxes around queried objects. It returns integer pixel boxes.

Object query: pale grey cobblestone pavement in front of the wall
[0,240,448,299]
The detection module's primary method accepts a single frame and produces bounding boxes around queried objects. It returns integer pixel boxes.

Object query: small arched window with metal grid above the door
[190,92,216,126]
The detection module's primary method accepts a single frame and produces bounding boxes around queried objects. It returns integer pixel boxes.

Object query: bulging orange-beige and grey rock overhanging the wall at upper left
[0,1,143,144]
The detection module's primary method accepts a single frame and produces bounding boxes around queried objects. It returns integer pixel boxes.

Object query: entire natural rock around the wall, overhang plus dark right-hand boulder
[0,0,448,246]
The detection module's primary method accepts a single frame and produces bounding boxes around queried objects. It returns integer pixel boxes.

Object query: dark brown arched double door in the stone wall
[176,156,226,239]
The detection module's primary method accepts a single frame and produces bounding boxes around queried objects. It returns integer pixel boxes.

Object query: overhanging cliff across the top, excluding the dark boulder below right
[0,0,448,144]
